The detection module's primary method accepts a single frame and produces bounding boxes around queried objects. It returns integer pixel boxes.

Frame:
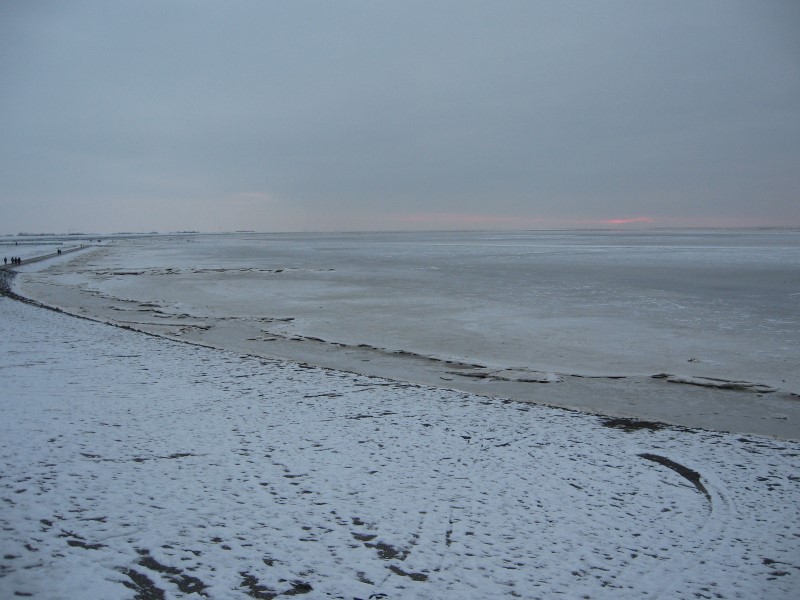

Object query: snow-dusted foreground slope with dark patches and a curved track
[0,298,800,600]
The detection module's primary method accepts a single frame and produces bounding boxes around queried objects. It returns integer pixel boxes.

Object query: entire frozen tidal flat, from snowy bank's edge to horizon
[10,230,800,439]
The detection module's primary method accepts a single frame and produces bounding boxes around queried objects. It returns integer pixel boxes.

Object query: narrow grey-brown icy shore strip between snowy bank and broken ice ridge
[7,251,800,440]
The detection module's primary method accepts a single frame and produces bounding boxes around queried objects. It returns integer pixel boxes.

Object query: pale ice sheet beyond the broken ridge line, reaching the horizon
[14,231,800,392]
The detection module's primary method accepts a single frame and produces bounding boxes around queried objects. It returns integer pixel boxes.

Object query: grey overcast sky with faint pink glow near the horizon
[0,0,800,234]
